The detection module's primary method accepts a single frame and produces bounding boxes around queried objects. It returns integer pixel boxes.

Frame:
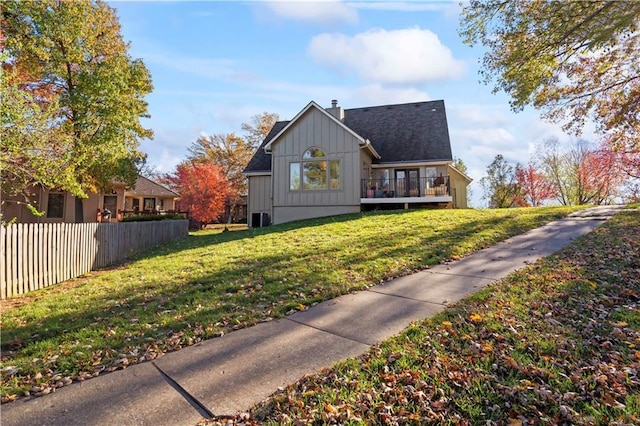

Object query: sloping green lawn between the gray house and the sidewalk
[0,207,576,402]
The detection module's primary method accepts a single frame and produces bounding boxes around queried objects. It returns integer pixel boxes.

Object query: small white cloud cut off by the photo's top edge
[262,0,358,24]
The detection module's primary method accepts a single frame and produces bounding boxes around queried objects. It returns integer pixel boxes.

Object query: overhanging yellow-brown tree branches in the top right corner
[460,0,640,170]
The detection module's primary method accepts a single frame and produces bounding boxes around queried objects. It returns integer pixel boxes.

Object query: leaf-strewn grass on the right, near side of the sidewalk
[246,209,640,425]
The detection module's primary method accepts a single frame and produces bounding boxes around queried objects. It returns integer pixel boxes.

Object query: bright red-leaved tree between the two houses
[163,161,229,224]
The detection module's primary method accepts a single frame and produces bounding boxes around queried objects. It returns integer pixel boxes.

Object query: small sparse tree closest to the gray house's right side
[480,154,522,209]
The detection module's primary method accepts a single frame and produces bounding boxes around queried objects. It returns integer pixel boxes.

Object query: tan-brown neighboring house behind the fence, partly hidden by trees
[2,176,180,223]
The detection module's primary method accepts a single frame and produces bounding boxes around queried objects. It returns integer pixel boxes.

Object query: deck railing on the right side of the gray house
[360,176,451,198]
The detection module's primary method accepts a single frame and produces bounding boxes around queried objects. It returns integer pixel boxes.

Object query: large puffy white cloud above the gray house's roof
[308,27,464,84]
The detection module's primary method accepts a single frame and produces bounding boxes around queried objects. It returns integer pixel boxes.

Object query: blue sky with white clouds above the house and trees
[109,1,596,207]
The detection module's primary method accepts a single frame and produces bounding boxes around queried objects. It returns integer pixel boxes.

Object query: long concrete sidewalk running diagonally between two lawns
[0,206,620,426]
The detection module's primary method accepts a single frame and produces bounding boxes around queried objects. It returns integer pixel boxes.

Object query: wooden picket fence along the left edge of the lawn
[0,220,189,299]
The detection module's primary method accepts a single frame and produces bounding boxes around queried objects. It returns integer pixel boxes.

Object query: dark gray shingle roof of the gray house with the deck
[245,100,453,173]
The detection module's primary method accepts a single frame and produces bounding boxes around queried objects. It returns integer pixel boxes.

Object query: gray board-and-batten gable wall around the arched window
[271,108,362,223]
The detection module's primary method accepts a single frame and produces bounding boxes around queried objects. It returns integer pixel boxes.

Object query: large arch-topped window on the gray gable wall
[289,147,341,191]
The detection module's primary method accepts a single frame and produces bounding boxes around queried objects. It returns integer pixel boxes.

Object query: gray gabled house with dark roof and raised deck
[244,101,471,227]
